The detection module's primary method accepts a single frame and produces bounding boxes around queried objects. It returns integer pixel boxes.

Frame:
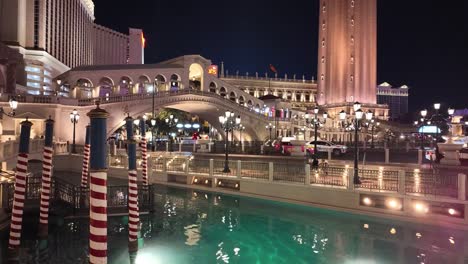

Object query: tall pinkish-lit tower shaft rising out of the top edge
[317,0,377,105]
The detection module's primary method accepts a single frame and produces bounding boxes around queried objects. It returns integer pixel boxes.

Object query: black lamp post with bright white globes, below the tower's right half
[339,102,373,184]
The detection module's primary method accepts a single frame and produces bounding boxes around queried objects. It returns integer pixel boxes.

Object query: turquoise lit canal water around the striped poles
[1,186,468,264]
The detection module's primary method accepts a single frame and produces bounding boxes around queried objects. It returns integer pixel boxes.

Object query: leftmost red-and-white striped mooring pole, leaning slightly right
[8,118,32,261]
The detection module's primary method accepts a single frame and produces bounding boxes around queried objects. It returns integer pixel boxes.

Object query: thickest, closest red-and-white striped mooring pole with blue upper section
[87,102,109,264]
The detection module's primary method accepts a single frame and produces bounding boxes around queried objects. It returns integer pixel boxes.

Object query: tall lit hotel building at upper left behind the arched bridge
[0,0,143,95]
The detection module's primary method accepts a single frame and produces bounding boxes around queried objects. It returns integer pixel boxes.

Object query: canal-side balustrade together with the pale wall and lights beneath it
[134,154,468,225]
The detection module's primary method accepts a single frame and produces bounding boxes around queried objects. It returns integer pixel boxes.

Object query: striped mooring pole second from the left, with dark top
[39,117,54,238]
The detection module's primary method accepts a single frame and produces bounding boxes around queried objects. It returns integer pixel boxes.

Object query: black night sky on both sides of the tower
[94,0,468,110]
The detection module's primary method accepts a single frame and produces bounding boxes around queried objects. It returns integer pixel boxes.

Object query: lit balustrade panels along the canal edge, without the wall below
[145,156,461,198]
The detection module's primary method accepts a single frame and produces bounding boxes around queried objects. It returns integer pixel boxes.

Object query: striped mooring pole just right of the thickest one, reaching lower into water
[125,116,140,252]
